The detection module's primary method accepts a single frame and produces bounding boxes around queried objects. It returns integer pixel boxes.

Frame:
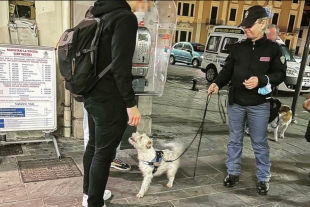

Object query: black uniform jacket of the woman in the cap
[214,35,287,106]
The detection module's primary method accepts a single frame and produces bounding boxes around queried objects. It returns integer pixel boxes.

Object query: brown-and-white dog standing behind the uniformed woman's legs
[268,105,292,142]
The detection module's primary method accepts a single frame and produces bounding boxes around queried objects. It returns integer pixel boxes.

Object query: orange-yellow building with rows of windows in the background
[175,0,305,52]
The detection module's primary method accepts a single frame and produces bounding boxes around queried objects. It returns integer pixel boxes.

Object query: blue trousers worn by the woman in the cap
[226,102,271,181]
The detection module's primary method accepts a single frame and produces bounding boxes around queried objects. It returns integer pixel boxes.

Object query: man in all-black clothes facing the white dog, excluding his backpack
[83,0,141,207]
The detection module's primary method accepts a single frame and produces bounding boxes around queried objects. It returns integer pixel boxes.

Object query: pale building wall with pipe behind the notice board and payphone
[0,0,152,138]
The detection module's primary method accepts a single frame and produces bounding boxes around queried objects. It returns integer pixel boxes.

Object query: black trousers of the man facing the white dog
[83,96,128,207]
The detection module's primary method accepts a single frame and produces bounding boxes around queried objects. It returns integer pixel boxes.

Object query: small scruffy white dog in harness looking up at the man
[128,133,183,198]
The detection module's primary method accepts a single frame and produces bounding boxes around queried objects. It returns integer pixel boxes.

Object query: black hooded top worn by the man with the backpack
[90,0,138,108]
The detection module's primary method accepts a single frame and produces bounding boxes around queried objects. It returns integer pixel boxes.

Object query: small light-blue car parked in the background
[169,42,205,68]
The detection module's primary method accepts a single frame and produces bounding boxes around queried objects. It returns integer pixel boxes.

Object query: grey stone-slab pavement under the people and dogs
[0,66,310,207]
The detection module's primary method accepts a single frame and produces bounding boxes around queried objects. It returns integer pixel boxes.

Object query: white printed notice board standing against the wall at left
[0,44,57,132]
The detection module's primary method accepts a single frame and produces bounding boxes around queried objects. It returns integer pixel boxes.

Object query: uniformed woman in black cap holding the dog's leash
[208,5,287,195]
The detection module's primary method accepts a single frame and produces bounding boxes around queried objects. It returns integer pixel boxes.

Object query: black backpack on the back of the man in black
[58,9,111,95]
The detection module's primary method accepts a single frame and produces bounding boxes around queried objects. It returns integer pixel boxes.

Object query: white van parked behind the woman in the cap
[200,26,310,92]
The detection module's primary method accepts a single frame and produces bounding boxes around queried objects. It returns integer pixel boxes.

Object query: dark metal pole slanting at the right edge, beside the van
[291,22,310,123]
